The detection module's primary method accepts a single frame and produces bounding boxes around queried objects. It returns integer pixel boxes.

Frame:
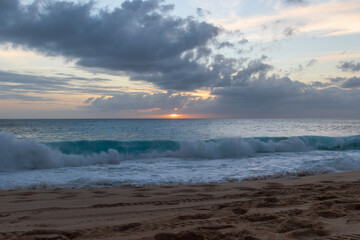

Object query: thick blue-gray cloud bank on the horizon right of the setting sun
[193,76,360,118]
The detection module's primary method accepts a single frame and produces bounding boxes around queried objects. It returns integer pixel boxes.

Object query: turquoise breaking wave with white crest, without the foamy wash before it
[0,132,360,171]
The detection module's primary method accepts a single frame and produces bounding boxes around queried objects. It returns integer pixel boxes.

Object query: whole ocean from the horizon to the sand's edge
[0,119,360,189]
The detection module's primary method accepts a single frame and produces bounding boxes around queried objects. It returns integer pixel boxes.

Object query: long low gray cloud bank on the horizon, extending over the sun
[85,74,360,118]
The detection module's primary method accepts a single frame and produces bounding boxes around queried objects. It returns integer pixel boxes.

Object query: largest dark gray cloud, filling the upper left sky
[0,0,242,90]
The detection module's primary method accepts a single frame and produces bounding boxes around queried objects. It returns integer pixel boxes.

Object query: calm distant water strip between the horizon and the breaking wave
[0,119,360,142]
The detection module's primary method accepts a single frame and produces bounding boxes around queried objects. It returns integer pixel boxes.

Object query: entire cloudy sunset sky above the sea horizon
[0,0,360,119]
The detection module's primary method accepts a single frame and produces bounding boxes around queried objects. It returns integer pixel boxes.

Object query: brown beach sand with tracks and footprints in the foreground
[0,171,360,240]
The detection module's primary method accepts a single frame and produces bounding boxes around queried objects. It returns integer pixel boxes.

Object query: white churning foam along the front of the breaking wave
[0,132,308,171]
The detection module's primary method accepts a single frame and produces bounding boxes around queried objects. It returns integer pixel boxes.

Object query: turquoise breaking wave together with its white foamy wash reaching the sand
[0,132,360,189]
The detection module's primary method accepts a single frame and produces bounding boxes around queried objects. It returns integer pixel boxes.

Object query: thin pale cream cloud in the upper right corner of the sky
[217,0,360,42]
